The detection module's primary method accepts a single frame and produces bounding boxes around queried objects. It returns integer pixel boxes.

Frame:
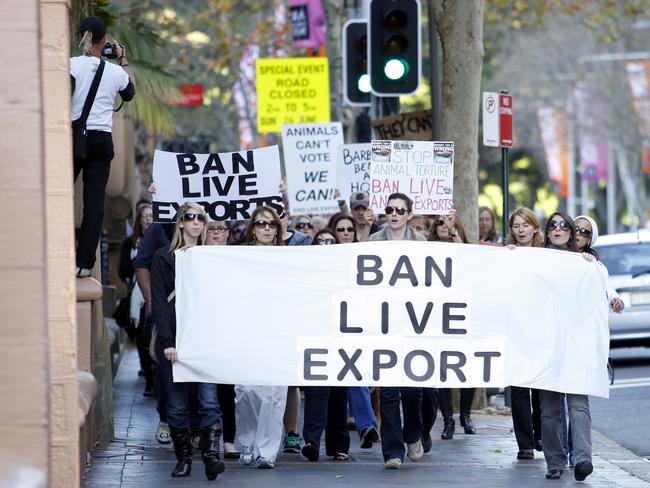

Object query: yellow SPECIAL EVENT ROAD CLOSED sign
[256,57,330,133]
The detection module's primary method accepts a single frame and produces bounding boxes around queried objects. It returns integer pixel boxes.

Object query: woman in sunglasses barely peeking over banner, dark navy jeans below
[301,229,350,461]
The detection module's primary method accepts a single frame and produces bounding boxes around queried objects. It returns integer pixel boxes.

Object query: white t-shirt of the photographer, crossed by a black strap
[70,56,129,132]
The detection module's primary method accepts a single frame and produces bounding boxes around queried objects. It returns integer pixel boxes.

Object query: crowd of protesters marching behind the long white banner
[111,192,623,481]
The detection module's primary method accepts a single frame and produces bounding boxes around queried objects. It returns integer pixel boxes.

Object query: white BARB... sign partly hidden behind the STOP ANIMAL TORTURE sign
[336,142,370,201]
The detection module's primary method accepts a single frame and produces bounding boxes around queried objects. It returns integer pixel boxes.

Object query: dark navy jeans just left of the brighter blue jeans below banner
[302,386,350,456]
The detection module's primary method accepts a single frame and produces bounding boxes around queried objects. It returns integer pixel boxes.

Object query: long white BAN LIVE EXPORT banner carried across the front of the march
[174,241,609,396]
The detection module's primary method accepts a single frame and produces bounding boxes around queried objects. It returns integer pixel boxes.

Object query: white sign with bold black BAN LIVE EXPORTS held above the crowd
[152,146,282,222]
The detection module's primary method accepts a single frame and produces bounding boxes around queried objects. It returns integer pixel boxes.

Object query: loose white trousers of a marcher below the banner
[235,385,287,462]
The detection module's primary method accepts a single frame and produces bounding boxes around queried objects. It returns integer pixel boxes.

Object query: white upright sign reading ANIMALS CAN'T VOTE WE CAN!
[282,122,343,215]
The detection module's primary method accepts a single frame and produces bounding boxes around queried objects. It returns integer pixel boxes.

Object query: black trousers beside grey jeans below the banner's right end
[510,386,542,450]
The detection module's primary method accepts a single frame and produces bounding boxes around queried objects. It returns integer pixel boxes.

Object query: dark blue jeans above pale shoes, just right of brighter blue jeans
[379,387,422,461]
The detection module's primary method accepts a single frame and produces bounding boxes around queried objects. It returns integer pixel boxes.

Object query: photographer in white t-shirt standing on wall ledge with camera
[70,17,135,278]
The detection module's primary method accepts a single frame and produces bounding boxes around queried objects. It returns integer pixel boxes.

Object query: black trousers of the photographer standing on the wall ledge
[74,130,114,269]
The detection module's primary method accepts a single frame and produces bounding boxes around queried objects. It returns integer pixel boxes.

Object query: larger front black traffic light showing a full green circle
[368,0,421,97]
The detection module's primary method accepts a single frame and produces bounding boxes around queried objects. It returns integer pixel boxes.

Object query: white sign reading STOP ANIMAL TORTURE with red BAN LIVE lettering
[370,141,454,215]
